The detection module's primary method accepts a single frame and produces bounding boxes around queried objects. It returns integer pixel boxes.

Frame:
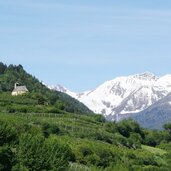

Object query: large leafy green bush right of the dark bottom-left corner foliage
[15,134,69,171]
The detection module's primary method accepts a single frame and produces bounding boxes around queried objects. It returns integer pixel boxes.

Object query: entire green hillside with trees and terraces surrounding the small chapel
[0,63,171,171]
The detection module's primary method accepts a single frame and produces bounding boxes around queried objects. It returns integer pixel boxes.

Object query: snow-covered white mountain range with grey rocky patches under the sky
[48,72,171,117]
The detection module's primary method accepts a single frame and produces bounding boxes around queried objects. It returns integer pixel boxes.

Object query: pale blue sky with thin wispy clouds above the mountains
[0,0,171,92]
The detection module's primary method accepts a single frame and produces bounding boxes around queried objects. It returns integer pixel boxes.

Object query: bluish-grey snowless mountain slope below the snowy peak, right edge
[119,93,171,129]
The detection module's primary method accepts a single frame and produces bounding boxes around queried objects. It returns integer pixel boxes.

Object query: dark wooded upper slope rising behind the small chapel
[0,63,92,114]
